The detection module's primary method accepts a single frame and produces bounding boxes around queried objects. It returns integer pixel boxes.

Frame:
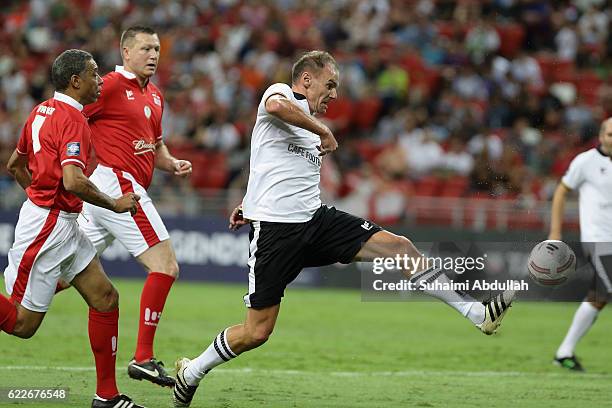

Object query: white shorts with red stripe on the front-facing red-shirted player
[78,165,170,257]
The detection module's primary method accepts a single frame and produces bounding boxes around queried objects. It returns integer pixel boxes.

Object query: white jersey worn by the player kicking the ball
[243,83,321,223]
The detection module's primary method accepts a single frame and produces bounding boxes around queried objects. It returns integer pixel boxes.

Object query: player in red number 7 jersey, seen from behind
[0,50,146,408]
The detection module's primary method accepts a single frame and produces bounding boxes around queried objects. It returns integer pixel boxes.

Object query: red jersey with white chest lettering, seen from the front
[84,66,164,189]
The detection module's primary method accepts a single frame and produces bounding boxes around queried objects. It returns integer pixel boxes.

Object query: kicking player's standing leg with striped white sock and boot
[173,304,280,407]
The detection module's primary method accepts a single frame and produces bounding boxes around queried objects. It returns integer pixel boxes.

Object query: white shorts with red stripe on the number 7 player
[4,200,96,312]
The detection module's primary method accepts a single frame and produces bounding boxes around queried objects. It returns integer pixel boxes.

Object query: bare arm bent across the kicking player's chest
[266,94,338,156]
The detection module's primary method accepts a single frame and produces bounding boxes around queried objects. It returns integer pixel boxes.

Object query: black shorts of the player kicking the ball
[244,205,382,309]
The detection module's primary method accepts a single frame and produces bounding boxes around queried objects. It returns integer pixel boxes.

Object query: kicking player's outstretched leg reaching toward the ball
[355,230,515,334]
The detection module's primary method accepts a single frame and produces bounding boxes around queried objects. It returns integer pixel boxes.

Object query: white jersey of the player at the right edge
[561,148,612,242]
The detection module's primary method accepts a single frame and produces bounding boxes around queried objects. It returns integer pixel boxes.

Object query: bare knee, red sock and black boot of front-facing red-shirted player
[128,239,179,387]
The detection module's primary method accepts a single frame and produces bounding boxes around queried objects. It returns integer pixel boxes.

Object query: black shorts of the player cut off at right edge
[583,242,612,302]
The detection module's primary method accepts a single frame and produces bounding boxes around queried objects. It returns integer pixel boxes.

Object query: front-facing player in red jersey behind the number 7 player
[79,26,191,387]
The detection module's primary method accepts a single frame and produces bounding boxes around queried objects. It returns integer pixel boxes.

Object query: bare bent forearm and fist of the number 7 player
[62,164,140,215]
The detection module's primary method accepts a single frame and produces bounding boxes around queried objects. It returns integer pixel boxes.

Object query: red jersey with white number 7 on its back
[17,92,91,213]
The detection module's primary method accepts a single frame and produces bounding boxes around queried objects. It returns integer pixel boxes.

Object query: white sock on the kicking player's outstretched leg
[410,268,485,324]
